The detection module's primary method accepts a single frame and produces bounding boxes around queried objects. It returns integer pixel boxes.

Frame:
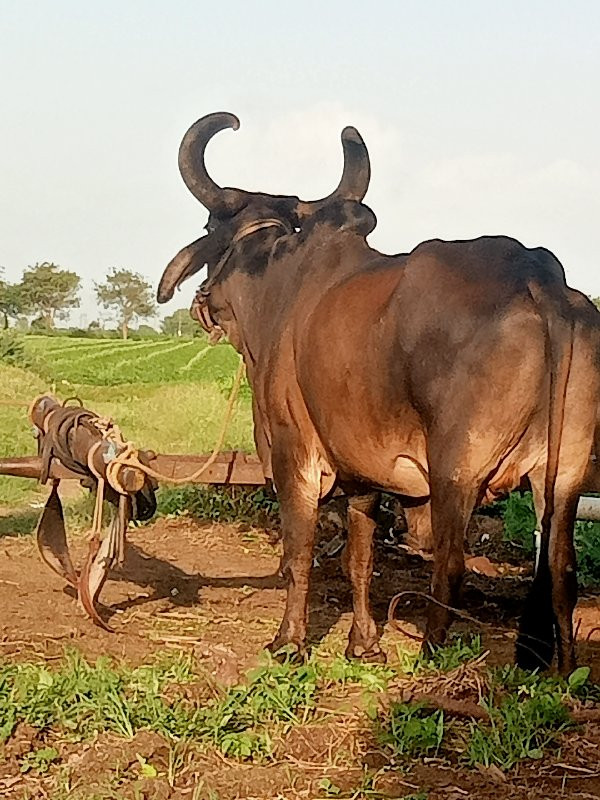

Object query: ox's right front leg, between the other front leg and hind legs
[344,494,385,663]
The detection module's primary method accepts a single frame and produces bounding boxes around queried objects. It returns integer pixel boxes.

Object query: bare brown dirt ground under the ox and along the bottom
[0,506,600,800]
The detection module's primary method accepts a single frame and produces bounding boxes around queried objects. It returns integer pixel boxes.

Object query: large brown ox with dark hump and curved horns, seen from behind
[158,113,599,672]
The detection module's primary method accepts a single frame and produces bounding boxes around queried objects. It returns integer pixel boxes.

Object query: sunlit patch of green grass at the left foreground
[0,650,321,769]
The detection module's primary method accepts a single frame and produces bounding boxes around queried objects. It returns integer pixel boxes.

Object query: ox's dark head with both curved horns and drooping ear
[157,112,375,332]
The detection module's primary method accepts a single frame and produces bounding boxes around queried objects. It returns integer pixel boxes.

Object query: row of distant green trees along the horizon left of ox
[0,261,198,339]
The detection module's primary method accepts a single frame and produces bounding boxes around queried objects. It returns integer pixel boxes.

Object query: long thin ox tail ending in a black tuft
[516,292,574,670]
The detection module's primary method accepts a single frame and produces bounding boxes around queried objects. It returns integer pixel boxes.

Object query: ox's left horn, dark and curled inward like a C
[179,111,240,212]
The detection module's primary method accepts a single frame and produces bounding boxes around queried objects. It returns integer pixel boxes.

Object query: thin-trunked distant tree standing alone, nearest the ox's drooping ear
[94,268,156,339]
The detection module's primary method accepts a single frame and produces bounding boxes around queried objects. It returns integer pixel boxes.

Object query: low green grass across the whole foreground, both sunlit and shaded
[0,646,596,776]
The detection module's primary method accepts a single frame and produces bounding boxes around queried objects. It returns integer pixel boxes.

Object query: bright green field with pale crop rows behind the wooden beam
[0,336,254,506]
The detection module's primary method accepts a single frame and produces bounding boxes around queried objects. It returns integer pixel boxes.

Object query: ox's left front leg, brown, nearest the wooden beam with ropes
[268,459,320,656]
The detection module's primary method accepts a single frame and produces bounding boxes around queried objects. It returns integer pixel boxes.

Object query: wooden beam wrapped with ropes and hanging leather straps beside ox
[0,395,266,631]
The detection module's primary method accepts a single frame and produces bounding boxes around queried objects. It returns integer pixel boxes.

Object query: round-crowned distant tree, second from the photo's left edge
[18,261,81,330]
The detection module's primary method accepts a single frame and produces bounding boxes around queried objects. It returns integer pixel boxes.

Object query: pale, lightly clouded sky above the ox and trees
[0,0,600,323]
